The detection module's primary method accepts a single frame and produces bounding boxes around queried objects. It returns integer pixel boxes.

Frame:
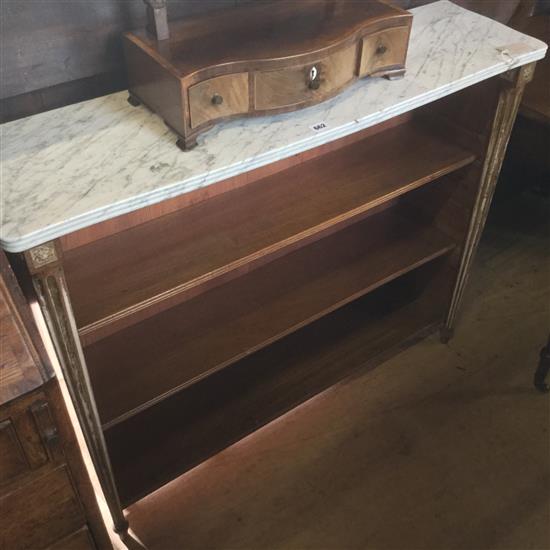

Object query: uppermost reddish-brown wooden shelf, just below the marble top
[64,121,474,343]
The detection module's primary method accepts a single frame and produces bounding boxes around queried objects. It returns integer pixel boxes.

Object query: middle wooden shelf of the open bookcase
[85,205,454,425]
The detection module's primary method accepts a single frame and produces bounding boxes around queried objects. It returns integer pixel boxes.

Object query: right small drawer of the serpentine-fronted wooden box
[359,27,409,76]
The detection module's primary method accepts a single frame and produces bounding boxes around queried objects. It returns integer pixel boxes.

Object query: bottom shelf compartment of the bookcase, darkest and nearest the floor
[105,257,451,506]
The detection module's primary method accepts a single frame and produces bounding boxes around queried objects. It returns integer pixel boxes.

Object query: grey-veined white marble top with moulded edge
[0,0,546,252]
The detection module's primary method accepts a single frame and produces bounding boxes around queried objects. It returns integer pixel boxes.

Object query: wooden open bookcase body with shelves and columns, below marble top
[17,66,532,532]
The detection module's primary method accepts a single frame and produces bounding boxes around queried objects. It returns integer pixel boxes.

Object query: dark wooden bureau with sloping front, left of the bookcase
[0,252,110,550]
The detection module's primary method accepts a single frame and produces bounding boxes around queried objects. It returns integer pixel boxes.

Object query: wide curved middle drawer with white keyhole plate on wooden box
[254,44,357,111]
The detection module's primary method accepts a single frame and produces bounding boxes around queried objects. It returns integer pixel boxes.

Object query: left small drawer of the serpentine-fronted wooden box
[189,73,248,128]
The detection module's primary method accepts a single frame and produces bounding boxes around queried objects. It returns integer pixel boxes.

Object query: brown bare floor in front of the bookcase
[128,188,550,550]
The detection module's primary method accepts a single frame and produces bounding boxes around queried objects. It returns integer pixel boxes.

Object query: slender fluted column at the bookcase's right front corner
[441,63,535,342]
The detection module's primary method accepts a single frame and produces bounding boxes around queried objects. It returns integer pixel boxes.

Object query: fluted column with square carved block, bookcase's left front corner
[25,241,128,534]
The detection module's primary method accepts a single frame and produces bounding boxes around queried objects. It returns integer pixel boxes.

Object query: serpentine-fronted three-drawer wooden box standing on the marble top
[124,0,412,149]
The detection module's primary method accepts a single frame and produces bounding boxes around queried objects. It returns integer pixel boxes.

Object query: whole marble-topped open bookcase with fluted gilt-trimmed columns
[2,2,546,544]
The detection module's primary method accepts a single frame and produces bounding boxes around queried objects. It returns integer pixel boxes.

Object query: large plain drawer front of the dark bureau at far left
[0,466,84,550]
